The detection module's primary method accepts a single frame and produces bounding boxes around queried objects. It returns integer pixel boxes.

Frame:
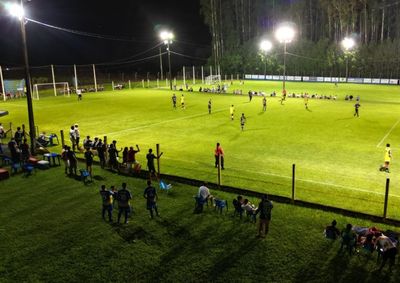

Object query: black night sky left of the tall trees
[0,0,211,73]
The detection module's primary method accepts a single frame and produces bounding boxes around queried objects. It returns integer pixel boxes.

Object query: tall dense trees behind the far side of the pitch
[200,0,400,78]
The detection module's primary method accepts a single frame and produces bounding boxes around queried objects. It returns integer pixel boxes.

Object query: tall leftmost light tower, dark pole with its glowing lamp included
[6,0,36,154]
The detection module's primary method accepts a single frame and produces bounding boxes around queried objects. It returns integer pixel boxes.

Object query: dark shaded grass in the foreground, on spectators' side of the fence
[0,164,400,283]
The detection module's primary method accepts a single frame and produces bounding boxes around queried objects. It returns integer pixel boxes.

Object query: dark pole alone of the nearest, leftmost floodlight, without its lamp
[20,7,36,155]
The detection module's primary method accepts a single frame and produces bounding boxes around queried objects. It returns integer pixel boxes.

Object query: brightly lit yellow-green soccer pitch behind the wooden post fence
[0,81,400,218]
